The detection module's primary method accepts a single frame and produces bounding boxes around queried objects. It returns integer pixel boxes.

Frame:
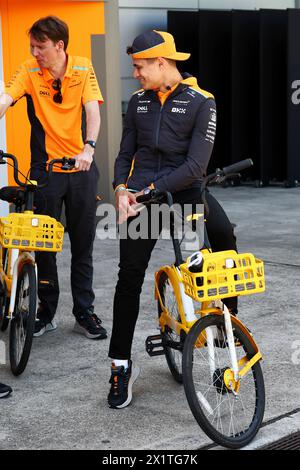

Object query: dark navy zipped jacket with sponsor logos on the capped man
[113,74,217,193]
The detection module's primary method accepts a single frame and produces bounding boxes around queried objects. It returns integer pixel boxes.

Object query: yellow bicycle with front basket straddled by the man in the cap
[137,159,265,449]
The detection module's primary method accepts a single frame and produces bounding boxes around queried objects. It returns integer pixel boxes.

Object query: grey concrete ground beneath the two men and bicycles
[0,187,300,451]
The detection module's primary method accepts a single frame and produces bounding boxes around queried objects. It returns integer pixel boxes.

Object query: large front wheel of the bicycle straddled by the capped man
[183,315,265,449]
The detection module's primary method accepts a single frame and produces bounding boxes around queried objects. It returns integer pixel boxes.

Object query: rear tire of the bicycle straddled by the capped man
[157,273,182,384]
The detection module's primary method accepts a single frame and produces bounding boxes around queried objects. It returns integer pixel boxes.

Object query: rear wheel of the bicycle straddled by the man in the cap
[157,273,183,383]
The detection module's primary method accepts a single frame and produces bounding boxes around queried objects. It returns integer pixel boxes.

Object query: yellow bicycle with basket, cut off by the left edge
[0,151,75,376]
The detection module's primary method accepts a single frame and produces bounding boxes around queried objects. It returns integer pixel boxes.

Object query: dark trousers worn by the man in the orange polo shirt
[31,162,99,321]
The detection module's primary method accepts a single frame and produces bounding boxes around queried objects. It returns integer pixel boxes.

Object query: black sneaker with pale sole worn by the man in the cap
[107,360,140,408]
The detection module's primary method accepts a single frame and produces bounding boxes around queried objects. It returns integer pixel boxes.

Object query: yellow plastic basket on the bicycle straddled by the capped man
[180,250,265,302]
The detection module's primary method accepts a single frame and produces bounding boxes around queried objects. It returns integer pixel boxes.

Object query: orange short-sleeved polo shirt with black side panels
[5,55,103,171]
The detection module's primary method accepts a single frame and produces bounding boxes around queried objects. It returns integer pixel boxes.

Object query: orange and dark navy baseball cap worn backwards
[127,30,191,60]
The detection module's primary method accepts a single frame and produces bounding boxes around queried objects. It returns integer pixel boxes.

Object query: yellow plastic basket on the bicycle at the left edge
[0,213,64,252]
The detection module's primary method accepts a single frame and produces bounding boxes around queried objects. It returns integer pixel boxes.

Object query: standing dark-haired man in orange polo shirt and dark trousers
[0,16,107,339]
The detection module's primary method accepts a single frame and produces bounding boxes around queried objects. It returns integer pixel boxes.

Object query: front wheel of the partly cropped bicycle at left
[9,264,37,376]
